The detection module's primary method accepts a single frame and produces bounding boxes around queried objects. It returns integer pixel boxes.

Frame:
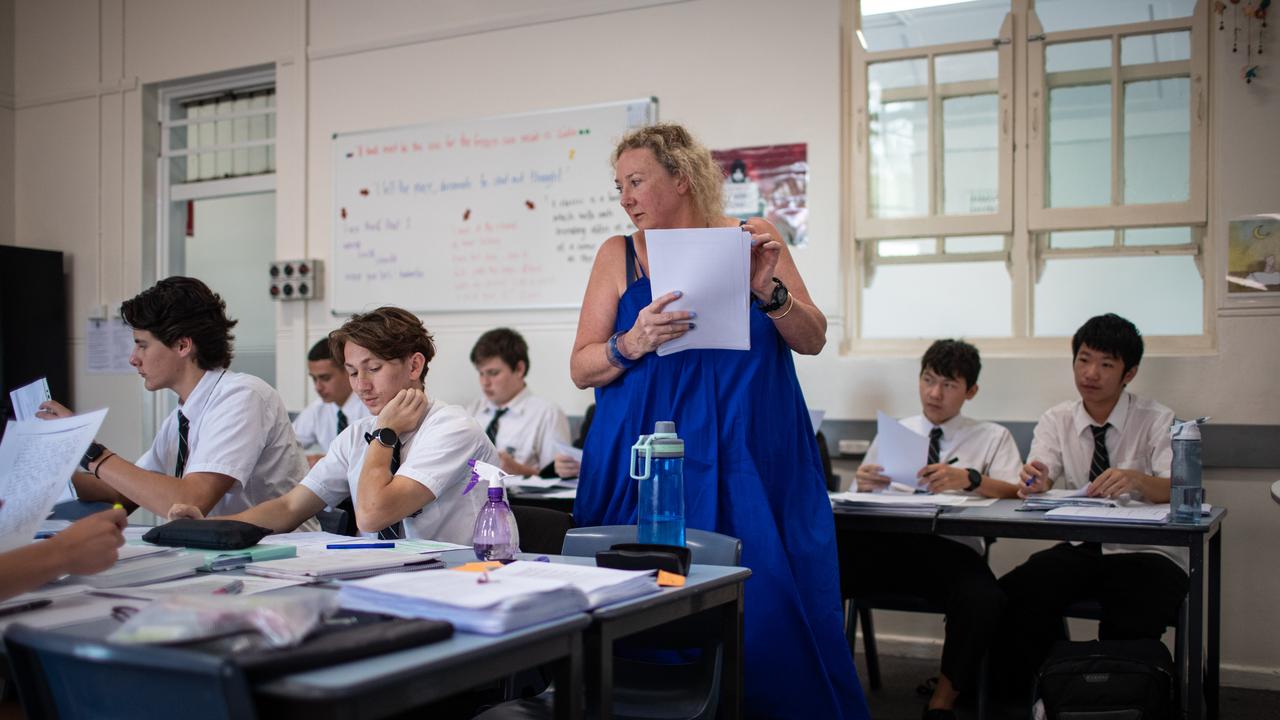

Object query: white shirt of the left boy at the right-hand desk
[863,415,1023,555]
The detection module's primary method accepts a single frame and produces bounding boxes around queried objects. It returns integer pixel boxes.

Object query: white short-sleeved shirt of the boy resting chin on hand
[302,400,498,546]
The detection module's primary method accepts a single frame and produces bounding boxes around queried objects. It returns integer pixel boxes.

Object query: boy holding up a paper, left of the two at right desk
[840,340,1021,720]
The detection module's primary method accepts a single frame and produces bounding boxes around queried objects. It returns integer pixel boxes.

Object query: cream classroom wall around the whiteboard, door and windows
[10,0,1280,684]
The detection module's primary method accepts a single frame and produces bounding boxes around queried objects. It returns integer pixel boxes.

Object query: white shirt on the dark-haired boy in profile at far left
[137,369,309,515]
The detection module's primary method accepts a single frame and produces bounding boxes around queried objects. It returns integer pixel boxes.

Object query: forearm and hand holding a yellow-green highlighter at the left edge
[0,507,128,600]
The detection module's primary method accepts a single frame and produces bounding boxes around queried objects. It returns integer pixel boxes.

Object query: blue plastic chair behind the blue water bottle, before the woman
[475,525,742,720]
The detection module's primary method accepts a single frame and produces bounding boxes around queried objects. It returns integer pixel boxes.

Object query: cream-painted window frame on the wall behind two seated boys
[841,0,1216,356]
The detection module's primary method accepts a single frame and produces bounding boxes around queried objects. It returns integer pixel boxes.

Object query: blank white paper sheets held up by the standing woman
[645,227,751,356]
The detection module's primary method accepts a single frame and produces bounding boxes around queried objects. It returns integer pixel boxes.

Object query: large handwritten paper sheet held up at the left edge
[0,410,106,552]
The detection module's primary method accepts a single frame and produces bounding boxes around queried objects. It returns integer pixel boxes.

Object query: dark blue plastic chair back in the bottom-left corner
[4,625,256,720]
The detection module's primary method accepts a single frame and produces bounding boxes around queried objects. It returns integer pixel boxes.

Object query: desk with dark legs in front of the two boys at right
[833,500,1226,720]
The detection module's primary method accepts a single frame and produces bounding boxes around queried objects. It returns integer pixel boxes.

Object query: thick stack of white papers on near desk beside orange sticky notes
[338,570,589,634]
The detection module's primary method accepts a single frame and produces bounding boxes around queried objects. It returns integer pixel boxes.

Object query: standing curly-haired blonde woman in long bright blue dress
[571,124,868,719]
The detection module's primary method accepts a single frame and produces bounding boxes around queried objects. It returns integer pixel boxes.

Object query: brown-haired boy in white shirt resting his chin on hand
[169,307,498,544]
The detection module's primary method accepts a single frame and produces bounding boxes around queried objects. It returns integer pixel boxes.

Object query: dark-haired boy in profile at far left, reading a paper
[37,277,307,516]
